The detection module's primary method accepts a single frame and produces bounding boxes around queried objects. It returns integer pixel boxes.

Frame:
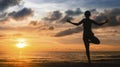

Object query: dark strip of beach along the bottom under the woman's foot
[0,61,120,67]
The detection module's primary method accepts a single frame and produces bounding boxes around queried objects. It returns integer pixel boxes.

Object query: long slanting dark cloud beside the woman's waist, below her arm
[55,27,82,37]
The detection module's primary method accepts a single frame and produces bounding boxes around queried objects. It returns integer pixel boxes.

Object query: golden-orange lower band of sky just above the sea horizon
[0,27,120,52]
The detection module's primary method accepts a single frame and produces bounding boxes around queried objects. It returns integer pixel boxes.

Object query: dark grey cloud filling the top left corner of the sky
[0,0,21,11]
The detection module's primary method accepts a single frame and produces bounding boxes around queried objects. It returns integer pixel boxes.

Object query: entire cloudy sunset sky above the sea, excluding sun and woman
[0,0,120,52]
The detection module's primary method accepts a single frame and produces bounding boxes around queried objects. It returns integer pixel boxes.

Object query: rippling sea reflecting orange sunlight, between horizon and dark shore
[0,51,120,63]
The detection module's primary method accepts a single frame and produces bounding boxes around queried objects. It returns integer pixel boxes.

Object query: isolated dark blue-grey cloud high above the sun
[9,8,33,20]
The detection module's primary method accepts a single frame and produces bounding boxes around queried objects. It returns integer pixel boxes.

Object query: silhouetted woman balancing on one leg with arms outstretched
[67,11,108,63]
